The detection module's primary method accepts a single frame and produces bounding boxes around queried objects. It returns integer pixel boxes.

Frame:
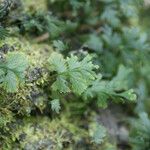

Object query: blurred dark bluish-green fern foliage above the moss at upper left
[21,12,65,38]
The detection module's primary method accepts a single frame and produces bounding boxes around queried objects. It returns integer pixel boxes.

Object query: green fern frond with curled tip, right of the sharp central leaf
[84,65,136,108]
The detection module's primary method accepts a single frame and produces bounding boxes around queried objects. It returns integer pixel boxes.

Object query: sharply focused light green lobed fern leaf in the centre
[48,52,98,95]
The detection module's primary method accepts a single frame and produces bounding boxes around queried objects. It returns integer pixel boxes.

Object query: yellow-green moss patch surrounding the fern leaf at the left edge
[0,37,52,149]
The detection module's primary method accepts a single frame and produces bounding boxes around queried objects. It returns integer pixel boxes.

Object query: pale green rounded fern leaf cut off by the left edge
[0,52,28,92]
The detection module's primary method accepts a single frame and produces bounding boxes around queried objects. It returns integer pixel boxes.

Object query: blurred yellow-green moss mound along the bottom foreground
[2,109,115,150]
